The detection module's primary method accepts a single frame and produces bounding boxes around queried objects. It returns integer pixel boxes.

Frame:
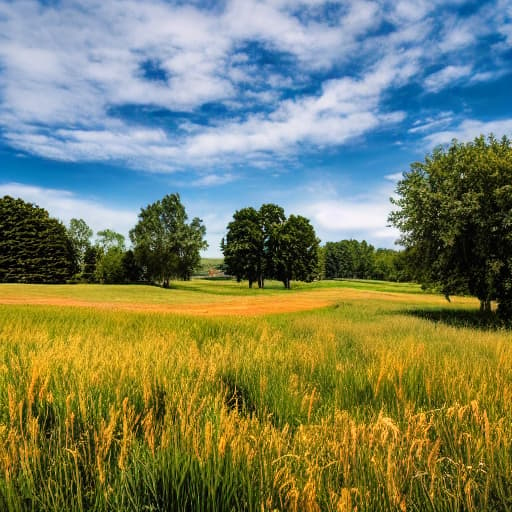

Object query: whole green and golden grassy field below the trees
[0,281,512,511]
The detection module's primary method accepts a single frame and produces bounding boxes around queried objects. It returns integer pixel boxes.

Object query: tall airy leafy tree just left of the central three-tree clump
[130,194,208,287]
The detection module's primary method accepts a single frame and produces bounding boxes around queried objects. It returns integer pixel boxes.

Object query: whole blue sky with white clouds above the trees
[0,0,512,257]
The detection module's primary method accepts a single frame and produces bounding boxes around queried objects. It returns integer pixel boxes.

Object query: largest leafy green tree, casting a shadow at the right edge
[389,136,512,318]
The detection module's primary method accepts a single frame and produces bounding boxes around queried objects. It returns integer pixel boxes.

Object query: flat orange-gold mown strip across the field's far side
[0,281,477,316]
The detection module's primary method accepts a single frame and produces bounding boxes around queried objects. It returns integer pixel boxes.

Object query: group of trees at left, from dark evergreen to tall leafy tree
[0,194,207,287]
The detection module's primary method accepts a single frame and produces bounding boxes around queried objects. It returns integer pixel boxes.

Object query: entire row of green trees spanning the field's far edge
[0,135,512,318]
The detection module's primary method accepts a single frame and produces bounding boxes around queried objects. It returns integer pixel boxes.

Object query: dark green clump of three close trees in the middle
[221,204,319,288]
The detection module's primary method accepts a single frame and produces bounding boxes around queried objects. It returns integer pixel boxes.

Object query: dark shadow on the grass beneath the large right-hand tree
[400,308,512,331]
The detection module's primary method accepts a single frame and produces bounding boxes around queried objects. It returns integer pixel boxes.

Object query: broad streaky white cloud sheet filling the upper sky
[0,0,508,172]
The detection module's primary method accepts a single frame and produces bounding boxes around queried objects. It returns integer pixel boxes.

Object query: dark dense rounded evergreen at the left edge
[0,196,77,283]
